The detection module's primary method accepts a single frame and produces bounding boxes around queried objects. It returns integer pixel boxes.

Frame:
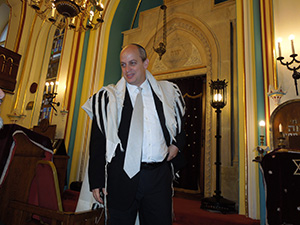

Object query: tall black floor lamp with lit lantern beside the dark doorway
[201,79,236,213]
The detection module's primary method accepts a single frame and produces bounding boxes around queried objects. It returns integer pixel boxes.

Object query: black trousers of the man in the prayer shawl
[108,162,173,225]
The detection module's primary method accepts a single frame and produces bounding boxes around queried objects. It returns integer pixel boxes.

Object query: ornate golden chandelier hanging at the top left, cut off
[29,0,103,32]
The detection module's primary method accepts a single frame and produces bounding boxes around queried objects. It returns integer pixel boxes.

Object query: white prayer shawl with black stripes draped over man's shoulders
[82,70,185,163]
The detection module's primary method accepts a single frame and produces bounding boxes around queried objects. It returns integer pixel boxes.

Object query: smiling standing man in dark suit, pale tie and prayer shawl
[83,44,185,225]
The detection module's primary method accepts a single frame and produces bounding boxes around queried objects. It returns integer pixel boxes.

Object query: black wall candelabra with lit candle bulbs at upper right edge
[277,35,300,95]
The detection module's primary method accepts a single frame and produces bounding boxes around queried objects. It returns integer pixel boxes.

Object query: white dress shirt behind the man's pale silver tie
[127,80,168,162]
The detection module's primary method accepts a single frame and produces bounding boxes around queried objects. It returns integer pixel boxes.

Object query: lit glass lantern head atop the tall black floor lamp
[210,79,227,108]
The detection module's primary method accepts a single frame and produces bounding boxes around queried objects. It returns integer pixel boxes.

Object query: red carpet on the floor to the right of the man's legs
[173,197,260,225]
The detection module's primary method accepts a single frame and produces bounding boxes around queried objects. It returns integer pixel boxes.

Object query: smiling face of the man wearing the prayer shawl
[120,45,149,86]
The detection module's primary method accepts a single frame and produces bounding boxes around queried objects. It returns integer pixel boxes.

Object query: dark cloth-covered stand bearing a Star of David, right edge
[261,149,300,225]
